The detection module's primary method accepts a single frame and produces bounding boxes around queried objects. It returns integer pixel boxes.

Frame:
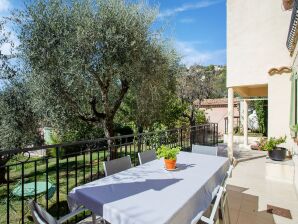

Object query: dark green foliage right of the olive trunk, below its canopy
[115,84,182,133]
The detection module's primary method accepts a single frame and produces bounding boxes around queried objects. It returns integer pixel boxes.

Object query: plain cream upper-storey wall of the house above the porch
[227,0,291,87]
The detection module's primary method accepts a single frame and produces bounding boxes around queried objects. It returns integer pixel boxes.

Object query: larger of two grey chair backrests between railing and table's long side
[103,156,131,176]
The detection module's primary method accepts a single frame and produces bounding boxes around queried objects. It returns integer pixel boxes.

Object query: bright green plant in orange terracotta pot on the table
[156,145,181,170]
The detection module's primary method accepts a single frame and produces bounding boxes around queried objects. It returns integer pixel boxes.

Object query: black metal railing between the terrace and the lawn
[0,124,218,223]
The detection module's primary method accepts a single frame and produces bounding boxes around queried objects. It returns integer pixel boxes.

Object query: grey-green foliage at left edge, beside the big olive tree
[0,81,40,149]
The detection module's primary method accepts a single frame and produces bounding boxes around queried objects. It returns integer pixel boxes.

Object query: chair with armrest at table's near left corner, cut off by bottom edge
[29,200,89,224]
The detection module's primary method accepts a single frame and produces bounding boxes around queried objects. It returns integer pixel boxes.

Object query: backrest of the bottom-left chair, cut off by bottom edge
[29,200,58,224]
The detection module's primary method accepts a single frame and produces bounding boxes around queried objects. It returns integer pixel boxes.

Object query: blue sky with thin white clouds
[0,0,226,66]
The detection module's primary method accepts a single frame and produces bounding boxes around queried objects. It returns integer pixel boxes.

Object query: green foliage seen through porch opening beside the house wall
[253,100,268,136]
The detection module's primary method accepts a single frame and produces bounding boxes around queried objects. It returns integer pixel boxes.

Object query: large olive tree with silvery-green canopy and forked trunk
[11,0,178,158]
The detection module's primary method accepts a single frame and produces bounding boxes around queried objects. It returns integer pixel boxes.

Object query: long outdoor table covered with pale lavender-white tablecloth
[68,152,229,224]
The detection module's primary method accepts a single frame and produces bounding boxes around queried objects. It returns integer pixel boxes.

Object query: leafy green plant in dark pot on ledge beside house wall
[260,136,287,161]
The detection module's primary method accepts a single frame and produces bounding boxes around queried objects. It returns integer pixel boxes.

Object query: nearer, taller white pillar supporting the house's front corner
[228,88,234,161]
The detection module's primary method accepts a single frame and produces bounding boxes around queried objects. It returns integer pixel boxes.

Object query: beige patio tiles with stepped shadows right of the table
[228,158,298,224]
